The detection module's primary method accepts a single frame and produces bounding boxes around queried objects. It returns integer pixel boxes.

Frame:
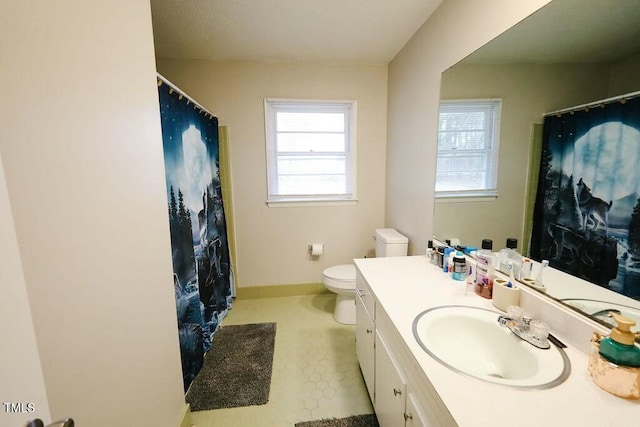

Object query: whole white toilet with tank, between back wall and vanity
[322,228,409,325]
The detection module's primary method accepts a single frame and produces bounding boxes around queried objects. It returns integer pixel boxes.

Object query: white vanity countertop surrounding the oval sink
[355,256,640,427]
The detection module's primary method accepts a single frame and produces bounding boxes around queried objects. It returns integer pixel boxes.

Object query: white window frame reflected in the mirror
[435,98,502,201]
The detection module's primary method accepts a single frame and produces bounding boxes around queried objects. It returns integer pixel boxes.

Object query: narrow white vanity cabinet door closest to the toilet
[356,295,375,402]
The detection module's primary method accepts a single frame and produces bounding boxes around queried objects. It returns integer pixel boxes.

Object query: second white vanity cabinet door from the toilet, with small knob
[374,331,407,427]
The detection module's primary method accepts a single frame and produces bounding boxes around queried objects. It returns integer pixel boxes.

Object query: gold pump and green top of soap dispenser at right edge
[600,313,640,368]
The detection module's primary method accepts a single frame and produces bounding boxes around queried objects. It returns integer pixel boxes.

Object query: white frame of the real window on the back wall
[264,98,357,207]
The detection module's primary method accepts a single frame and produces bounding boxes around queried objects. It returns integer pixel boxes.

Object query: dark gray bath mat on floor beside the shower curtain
[186,323,276,411]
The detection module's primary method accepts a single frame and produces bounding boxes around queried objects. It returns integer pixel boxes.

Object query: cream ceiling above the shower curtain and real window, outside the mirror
[151,0,442,63]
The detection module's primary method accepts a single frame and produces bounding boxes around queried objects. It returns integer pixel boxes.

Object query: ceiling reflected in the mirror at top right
[463,0,640,64]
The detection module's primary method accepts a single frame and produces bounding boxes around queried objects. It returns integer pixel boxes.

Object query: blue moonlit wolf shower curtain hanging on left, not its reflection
[158,78,233,392]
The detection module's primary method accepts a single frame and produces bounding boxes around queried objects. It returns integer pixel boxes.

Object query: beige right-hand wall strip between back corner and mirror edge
[385,0,549,254]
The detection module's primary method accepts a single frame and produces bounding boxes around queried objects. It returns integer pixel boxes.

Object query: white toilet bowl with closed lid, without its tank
[322,264,356,325]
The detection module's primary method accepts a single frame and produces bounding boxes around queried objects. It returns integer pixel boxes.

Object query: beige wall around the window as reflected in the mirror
[433,64,610,250]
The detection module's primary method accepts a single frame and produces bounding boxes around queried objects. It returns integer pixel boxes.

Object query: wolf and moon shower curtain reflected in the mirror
[530,98,640,299]
